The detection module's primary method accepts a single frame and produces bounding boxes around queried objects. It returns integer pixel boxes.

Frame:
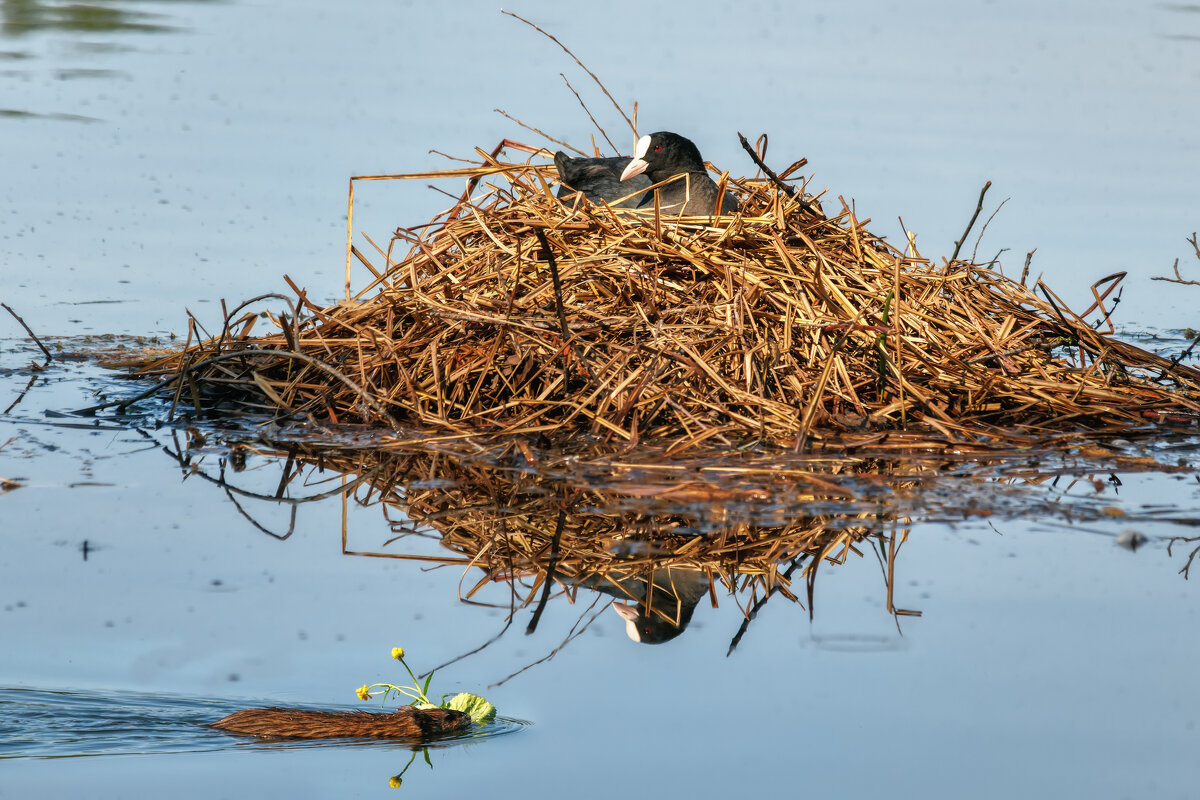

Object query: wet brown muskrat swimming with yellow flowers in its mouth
[209,705,470,739]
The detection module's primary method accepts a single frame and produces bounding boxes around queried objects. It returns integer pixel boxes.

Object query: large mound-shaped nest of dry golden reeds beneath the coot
[129,138,1200,452]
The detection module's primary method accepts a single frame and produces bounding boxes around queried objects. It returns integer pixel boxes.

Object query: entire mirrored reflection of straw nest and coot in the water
[159,428,1190,646]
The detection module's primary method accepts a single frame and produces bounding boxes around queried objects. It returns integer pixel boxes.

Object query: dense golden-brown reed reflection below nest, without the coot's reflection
[404,455,865,602]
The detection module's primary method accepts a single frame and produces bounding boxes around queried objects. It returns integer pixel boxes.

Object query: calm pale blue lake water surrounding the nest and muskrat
[0,0,1200,798]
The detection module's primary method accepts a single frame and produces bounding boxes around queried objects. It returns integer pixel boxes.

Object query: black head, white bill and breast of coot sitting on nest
[620,131,738,217]
